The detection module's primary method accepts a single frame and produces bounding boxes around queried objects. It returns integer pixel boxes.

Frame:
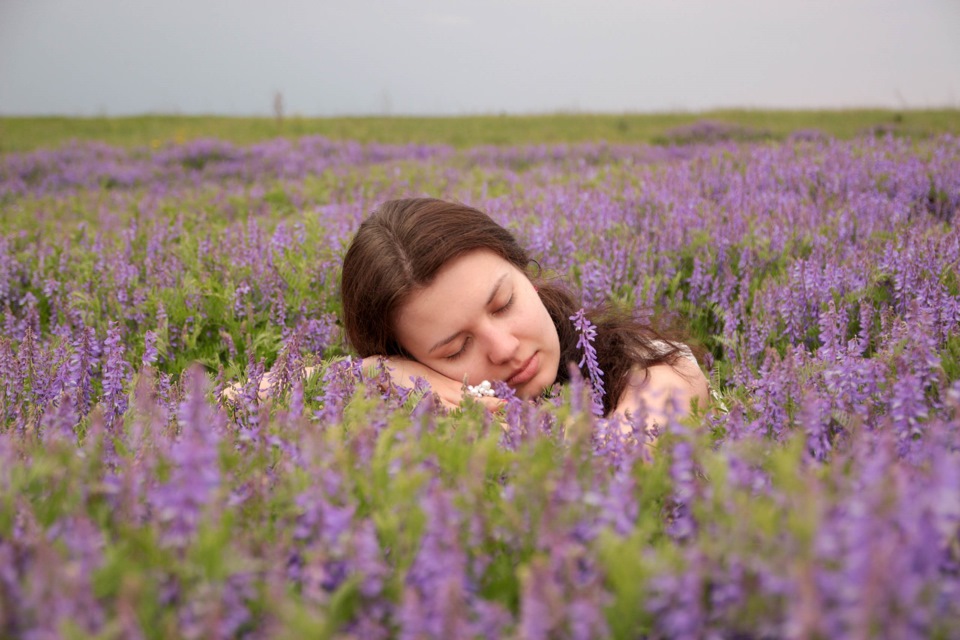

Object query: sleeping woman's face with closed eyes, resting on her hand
[395,249,560,398]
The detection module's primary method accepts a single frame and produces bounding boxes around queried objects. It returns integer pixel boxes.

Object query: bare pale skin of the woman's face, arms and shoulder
[225,250,709,438]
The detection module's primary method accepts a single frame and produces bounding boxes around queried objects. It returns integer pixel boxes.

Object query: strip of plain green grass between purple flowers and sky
[0,109,960,153]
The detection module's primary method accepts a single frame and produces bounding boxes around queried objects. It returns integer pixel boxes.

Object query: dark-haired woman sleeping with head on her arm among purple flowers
[341,198,708,424]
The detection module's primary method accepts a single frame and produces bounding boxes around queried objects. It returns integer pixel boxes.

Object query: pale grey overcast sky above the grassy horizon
[0,0,960,115]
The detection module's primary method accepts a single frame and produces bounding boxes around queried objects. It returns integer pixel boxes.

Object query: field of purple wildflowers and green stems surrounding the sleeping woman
[0,136,960,640]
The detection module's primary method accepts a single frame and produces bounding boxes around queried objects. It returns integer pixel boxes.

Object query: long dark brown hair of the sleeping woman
[340,198,680,414]
